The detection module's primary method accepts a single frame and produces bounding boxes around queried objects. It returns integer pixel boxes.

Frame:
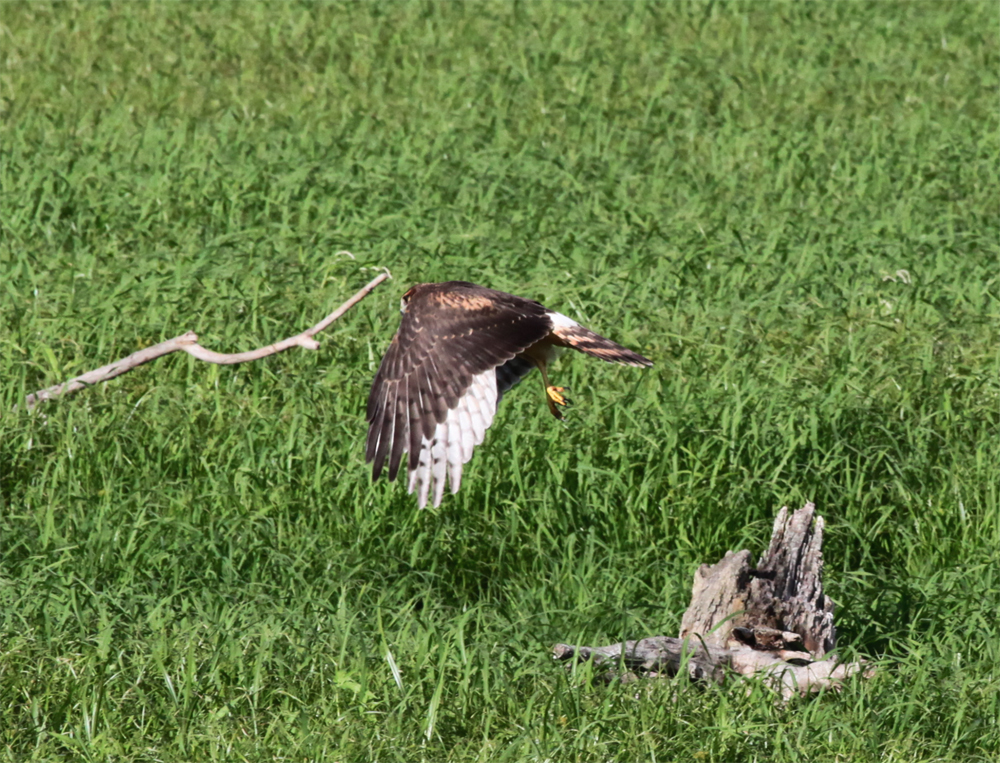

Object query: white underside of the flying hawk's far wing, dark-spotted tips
[408,368,497,508]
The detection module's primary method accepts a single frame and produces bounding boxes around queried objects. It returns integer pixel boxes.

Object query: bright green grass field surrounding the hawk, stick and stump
[0,2,1000,763]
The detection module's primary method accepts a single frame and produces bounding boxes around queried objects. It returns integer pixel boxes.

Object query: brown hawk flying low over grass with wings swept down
[365,281,653,508]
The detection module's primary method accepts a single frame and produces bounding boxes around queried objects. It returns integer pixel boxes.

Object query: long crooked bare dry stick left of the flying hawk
[24,270,391,410]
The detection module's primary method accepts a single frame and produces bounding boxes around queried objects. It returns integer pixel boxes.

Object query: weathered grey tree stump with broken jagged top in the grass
[553,503,872,699]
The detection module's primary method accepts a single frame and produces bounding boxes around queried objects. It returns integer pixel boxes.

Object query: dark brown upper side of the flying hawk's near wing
[365,281,552,480]
